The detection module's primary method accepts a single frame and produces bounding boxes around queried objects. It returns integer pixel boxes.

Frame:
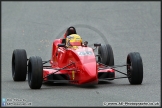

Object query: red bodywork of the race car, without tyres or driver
[43,39,115,85]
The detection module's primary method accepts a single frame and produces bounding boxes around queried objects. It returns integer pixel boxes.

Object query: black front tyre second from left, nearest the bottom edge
[28,56,43,89]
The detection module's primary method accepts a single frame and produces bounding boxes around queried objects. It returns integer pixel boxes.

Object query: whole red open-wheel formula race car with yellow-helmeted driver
[12,27,143,89]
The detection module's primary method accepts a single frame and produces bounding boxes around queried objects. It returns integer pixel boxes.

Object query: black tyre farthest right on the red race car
[126,52,143,84]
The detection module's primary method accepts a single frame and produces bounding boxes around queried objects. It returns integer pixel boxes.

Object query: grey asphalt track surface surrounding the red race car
[1,1,161,106]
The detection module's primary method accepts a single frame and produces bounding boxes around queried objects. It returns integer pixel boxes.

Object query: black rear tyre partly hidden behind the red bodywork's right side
[98,44,114,66]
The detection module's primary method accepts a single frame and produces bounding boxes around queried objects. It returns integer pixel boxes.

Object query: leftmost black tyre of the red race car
[12,49,27,81]
